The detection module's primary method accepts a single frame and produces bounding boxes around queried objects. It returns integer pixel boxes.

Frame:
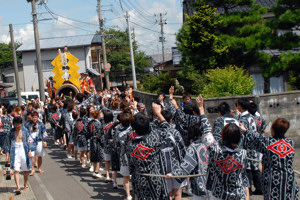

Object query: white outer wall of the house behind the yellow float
[22,47,91,92]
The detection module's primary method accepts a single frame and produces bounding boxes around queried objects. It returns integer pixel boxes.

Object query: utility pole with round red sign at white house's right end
[97,0,110,89]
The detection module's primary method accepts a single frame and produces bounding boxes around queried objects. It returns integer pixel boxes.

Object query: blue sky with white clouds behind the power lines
[0,0,182,54]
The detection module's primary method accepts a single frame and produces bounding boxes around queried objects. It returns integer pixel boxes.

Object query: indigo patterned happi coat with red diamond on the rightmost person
[246,130,299,200]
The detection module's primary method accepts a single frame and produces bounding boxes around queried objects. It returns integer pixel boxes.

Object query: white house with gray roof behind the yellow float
[17,34,101,92]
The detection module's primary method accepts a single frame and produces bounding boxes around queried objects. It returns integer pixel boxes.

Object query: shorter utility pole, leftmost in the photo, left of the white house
[9,24,22,106]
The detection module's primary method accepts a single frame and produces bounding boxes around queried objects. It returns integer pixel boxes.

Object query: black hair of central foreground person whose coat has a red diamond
[132,113,150,135]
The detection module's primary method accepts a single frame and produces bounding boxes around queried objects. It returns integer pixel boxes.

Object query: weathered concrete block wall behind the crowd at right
[134,91,300,147]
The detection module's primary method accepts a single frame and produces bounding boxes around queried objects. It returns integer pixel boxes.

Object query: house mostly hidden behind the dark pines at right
[183,0,300,95]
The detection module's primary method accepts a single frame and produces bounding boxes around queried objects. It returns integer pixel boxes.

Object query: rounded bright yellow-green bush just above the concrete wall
[202,66,255,97]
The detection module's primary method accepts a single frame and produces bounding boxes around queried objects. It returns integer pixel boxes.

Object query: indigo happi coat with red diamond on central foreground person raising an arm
[126,121,170,200]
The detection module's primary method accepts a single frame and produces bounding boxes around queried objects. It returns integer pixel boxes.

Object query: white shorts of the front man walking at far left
[14,142,29,171]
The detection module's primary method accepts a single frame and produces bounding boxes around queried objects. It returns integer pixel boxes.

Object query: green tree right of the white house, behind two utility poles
[97,29,151,81]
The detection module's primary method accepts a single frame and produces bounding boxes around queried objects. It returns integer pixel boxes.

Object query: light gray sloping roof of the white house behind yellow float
[17,34,101,52]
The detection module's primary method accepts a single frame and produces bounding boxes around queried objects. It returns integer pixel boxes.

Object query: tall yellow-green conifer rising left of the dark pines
[177,0,227,94]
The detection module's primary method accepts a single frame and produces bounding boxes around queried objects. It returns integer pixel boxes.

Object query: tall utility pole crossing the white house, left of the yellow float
[27,0,45,102]
